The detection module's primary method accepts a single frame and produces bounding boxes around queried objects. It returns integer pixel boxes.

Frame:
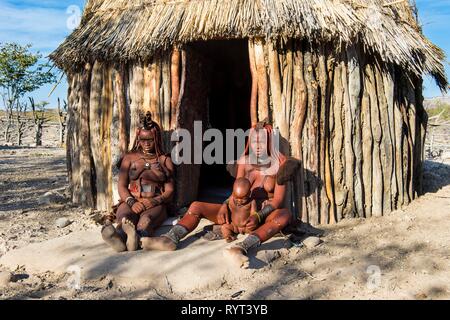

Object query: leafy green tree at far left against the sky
[0,43,56,142]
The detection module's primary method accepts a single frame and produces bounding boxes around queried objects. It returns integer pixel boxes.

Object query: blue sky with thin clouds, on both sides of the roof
[0,0,450,106]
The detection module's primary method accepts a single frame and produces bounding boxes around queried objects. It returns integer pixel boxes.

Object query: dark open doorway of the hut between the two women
[194,40,251,202]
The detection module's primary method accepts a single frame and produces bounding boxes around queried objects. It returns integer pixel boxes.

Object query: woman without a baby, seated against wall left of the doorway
[102,112,174,252]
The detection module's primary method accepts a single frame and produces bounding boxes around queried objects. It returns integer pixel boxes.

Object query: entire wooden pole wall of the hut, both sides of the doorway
[67,39,427,221]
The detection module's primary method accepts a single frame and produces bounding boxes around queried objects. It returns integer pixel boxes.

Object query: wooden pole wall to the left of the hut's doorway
[67,50,183,211]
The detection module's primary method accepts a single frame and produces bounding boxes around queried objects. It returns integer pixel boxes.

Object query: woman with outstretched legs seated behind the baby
[141,123,292,268]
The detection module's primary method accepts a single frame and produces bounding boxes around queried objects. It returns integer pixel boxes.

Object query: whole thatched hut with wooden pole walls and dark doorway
[51,0,447,224]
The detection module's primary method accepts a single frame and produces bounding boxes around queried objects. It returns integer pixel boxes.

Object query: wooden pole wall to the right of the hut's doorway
[249,39,426,224]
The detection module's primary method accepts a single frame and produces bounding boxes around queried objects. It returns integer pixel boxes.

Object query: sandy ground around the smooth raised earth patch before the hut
[0,147,450,299]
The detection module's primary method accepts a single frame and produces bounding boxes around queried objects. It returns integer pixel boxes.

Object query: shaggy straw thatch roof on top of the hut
[51,0,447,87]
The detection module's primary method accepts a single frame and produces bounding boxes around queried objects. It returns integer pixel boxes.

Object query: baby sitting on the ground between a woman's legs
[221,178,257,242]
